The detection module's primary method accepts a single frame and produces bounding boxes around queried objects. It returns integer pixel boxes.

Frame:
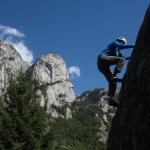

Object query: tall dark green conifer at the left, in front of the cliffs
[0,73,50,150]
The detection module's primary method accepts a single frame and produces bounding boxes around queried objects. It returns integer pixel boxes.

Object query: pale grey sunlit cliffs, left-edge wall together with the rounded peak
[0,41,75,118]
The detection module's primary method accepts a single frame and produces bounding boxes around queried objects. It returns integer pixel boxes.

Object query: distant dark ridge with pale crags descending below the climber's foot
[77,89,116,144]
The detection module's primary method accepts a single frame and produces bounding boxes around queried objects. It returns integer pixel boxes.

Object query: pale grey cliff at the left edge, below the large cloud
[0,41,28,96]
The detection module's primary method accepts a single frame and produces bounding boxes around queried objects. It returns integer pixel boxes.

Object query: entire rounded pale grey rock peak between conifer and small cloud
[29,54,75,113]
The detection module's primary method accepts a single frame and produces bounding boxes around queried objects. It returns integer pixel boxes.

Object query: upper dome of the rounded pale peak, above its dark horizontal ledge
[31,54,70,84]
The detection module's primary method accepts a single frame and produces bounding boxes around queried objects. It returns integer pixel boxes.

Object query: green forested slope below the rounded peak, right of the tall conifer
[48,102,105,150]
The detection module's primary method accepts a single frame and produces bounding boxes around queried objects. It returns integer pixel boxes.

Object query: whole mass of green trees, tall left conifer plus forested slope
[0,73,105,150]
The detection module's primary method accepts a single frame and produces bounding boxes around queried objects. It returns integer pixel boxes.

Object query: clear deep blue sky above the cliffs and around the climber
[0,0,149,93]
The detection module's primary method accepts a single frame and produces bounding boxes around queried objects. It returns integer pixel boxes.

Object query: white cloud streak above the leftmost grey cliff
[0,25,33,64]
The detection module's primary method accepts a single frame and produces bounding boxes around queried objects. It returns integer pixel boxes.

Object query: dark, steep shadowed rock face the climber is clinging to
[107,6,150,150]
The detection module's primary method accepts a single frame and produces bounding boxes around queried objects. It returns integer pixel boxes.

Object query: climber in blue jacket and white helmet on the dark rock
[97,37,134,107]
